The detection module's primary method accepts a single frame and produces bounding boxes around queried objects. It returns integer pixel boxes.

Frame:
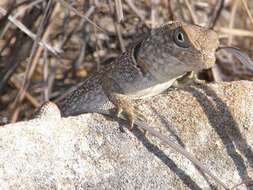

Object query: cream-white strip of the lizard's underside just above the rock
[126,78,176,99]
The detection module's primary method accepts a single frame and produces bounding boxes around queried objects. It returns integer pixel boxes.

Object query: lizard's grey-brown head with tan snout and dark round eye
[136,21,219,81]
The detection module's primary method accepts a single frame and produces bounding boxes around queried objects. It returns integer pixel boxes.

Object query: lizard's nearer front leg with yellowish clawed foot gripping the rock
[102,77,146,130]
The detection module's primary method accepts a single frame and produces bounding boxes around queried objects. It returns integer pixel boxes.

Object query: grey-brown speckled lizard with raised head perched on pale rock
[56,21,219,128]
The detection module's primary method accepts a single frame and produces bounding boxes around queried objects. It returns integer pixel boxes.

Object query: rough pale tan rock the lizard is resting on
[0,81,253,190]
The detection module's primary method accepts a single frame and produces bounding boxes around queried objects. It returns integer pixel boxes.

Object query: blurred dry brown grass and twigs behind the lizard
[0,0,253,124]
